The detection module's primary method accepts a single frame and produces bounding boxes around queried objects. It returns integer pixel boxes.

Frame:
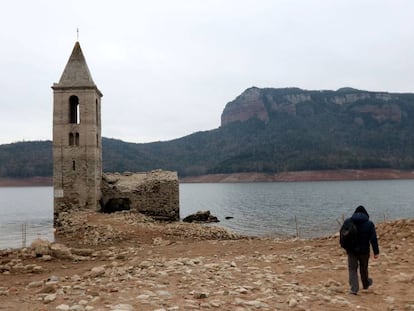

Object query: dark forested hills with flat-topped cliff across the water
[0,87,414,177]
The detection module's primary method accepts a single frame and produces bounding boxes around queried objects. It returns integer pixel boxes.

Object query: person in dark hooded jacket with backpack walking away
[340,205,379,295]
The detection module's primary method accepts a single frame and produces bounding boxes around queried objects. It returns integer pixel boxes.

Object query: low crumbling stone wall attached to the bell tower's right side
[101,170,180,221]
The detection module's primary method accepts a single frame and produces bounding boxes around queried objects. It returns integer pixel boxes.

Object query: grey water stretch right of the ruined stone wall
[180,180,414,237]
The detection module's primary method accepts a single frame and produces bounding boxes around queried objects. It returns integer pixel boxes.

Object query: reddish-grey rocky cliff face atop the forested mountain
[221,87,404,126]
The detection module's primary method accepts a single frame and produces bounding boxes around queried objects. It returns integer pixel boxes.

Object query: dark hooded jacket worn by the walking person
[351,206,379,255]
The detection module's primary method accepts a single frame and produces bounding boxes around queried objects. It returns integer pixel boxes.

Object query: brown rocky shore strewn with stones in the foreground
[0,211,414,311]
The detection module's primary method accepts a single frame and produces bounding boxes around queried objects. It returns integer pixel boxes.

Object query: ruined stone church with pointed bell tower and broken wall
[52,42,179,224]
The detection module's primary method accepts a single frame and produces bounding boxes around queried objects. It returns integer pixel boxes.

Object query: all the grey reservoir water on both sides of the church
[0,180,414,249]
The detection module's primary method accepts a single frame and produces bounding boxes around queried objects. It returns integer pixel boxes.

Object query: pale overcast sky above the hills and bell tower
[0,0,414,144]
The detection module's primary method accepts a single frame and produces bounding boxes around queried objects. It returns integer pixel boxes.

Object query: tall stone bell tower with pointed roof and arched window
[52,42,102,224]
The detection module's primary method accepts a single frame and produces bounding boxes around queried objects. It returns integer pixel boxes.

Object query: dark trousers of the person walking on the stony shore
[348,253,369,293]
